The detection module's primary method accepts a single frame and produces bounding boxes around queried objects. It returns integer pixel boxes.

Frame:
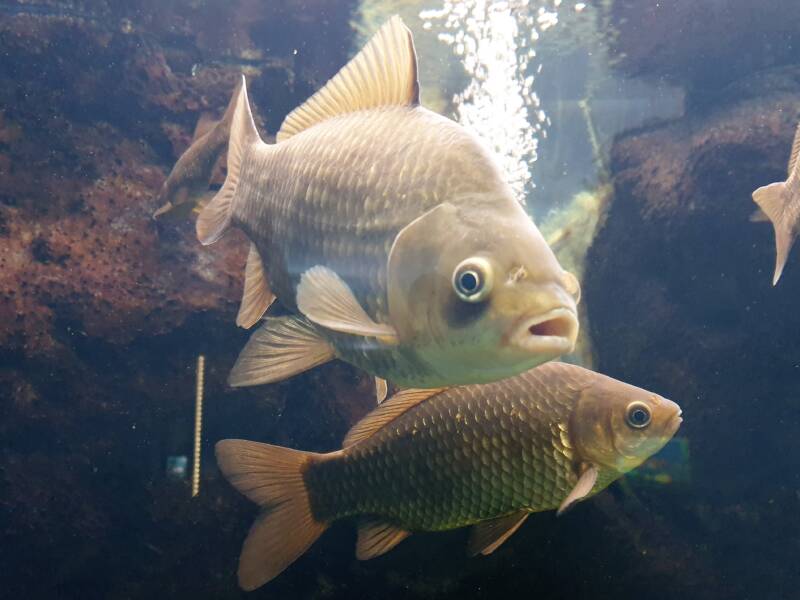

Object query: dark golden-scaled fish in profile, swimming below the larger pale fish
[216,363,681,590]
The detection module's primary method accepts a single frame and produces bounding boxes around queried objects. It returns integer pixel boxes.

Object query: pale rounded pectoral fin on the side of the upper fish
[297,266,397,343]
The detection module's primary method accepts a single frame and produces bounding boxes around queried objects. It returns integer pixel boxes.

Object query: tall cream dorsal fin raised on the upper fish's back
[276,15,419,142]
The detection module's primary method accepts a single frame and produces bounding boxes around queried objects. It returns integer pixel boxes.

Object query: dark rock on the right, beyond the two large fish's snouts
[583,67,800,598]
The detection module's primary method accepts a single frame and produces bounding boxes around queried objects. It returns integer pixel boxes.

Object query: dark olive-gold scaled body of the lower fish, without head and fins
[306,372,577,530]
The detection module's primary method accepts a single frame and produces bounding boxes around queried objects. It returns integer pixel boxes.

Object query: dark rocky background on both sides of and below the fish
[0,0,800,600]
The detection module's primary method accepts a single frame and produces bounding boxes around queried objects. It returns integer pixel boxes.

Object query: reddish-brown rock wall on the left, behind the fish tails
[0,0,374,598]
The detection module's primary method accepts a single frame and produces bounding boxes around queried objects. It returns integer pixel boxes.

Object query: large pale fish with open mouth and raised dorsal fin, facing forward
[197,17,578,388]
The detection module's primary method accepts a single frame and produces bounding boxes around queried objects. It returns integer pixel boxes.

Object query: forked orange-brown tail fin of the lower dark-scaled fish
[216,440,328,591]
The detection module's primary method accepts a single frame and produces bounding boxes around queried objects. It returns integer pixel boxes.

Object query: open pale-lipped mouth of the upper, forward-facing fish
[511,308,578,358]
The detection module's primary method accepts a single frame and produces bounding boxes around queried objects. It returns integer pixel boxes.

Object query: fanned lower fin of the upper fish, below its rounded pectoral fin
[228,317,334,387]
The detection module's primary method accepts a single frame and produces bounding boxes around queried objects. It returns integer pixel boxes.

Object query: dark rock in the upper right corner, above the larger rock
[602,0,800,101]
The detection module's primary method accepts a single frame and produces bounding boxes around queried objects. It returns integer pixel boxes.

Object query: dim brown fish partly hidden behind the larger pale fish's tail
[153,78,240,219]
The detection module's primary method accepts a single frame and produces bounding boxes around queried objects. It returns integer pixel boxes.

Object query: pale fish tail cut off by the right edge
[753,123,800,285]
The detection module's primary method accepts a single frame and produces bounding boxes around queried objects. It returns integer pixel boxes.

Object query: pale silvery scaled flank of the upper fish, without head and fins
[234,107,502,321]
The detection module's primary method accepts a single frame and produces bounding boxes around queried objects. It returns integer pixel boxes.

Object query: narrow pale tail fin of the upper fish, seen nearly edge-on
[196,76,261,246]
